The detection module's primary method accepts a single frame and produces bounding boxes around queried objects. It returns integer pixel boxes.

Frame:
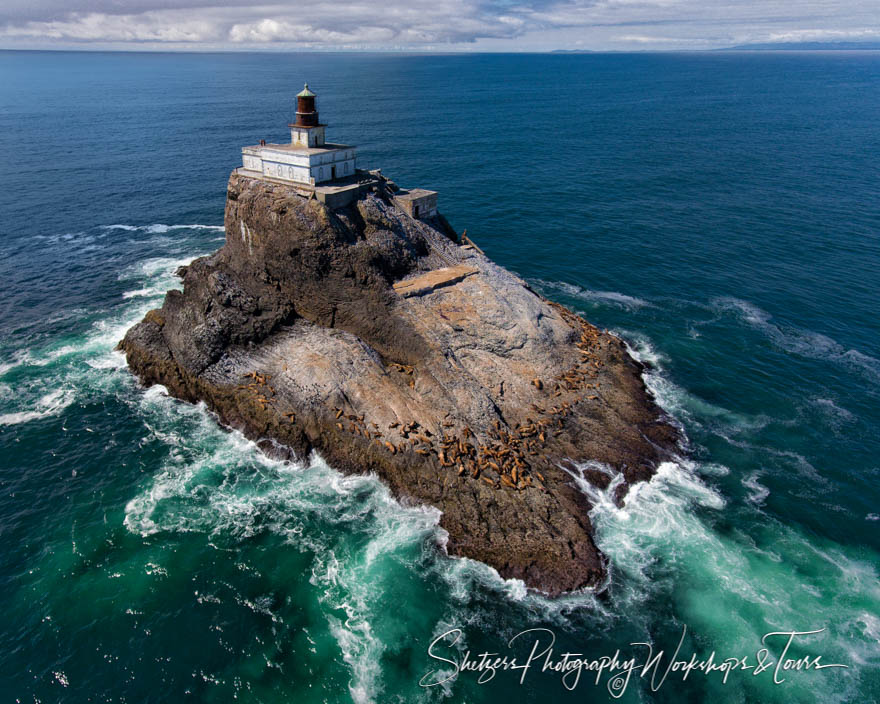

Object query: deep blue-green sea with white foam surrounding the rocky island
[0,52,880,704]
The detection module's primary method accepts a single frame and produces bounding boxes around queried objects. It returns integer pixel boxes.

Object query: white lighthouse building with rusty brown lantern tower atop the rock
[241,83,357,186]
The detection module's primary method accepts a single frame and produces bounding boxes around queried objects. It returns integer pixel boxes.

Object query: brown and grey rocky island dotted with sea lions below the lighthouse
[120,174,676,595]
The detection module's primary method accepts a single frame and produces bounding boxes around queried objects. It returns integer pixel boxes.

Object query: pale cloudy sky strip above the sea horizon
[0,0,880,51]
